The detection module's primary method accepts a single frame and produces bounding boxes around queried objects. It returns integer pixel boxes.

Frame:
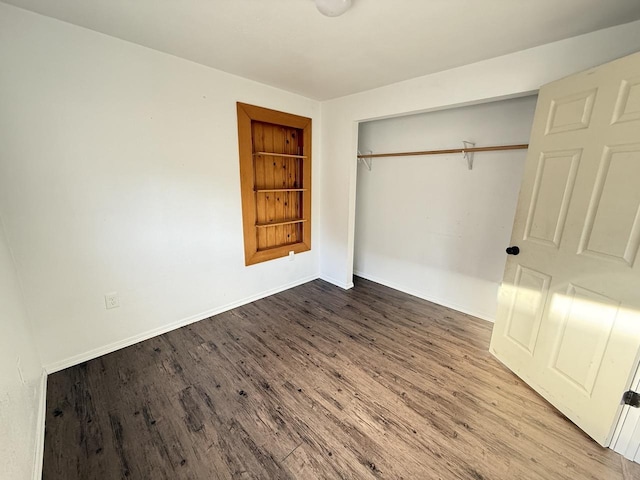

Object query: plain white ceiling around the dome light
[3,0,640,100]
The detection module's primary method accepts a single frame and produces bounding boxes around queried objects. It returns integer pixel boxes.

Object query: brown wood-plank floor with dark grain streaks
[43,278,640,480]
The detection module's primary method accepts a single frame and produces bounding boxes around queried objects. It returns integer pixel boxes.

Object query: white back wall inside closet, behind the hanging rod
[354,97,536,320]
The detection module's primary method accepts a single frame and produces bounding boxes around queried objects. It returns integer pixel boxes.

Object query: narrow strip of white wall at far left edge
[0,220,45,480]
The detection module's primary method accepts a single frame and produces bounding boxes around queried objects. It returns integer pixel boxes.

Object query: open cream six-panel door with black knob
[491,53,640,446]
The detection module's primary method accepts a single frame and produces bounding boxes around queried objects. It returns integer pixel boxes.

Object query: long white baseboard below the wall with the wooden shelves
[44,275,318,374]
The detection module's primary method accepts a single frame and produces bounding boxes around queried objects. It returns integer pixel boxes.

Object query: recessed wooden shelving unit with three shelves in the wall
[237,103,311,265]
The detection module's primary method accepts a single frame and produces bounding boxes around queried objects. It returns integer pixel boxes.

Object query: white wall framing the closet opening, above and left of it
[320,21,640,288]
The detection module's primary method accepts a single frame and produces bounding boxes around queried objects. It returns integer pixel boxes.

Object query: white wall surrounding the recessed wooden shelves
[0,3,320,371]
